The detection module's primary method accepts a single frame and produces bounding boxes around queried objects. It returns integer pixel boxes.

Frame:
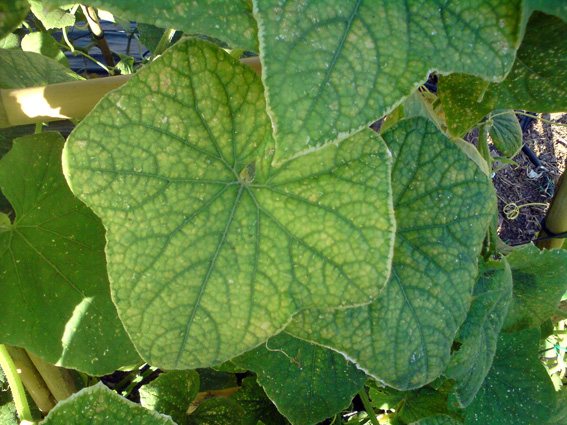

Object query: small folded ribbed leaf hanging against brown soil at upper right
[488,111,522,158]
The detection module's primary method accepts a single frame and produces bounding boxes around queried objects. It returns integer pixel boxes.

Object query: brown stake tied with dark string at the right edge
[536,171,567,249]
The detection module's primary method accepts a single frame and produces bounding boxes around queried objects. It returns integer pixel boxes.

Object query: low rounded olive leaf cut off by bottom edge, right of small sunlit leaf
[185,397,245,425]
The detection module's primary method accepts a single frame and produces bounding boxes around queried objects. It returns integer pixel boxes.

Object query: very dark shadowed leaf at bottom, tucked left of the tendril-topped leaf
[232,376,288,425]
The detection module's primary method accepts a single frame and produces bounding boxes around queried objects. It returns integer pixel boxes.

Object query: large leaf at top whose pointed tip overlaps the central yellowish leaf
[253,0,521,162]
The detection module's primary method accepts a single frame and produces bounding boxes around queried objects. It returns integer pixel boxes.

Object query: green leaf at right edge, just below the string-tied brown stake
[503,245,567,332]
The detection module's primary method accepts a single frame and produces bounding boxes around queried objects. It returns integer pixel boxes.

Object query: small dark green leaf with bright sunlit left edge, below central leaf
[140,370,199,424]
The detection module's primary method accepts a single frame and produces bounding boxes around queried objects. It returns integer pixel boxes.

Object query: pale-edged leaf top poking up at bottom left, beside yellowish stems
[41,383,175,425]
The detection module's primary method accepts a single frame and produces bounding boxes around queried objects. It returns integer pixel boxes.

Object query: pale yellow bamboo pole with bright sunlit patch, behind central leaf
[0,57,261,128]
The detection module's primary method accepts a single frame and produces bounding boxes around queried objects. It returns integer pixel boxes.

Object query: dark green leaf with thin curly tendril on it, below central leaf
[233,332,366,425]
